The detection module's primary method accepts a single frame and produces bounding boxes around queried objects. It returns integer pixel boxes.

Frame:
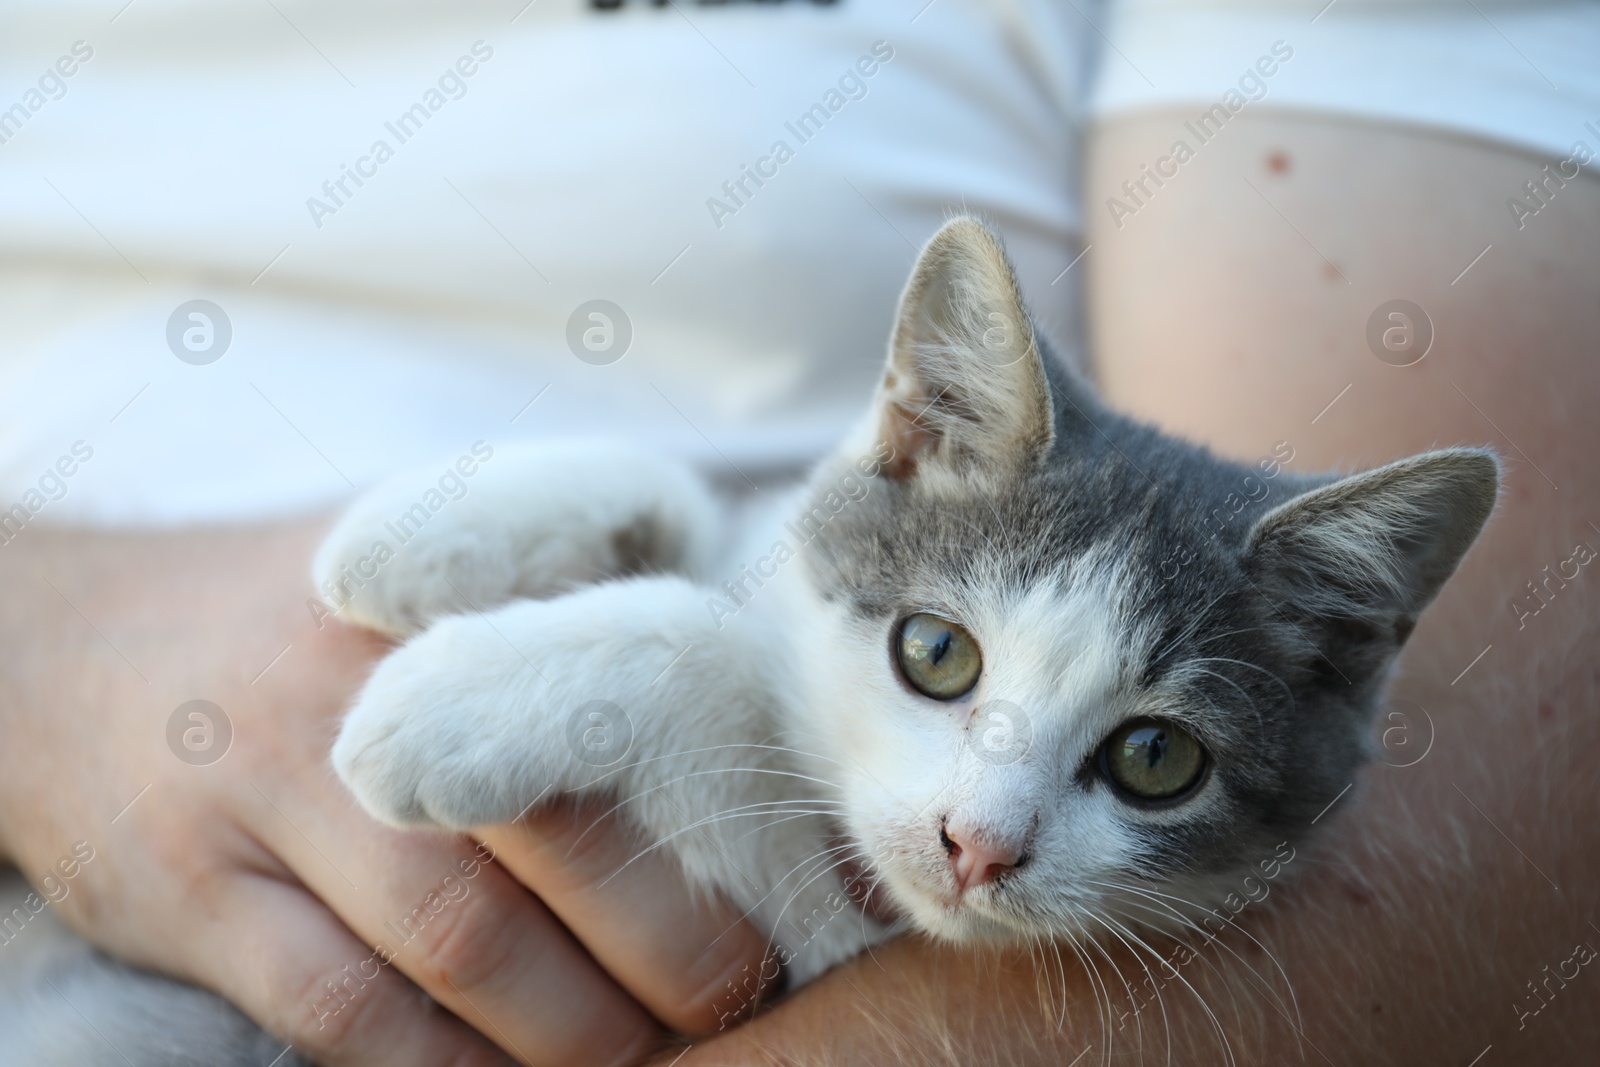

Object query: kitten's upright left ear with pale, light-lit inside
[878,218,1053,478]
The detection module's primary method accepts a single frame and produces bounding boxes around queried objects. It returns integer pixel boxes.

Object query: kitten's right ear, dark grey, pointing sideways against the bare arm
[1245,448,1499,662]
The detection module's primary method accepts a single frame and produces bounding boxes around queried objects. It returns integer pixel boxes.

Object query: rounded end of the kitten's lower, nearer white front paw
[333,616,558,830]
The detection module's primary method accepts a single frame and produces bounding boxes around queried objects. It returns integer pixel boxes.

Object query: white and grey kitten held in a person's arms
[3,218,1498,1064]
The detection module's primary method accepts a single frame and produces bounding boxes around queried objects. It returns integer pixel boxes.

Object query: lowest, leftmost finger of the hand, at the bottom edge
[197,877,510,1067]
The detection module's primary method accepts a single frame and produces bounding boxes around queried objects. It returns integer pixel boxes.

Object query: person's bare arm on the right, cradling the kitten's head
[665,117,1600,1065]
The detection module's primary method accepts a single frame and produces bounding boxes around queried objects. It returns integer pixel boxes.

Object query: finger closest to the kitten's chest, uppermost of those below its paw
[480,803,779,1033]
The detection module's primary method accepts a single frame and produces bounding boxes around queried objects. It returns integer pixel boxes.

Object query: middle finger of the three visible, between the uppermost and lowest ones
[264,792,661,1067]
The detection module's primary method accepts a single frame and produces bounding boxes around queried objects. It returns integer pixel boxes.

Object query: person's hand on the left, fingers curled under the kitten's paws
[0,523,765,1067]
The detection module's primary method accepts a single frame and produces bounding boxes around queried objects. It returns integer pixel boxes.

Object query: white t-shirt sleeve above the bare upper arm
[1093,0,1600,162]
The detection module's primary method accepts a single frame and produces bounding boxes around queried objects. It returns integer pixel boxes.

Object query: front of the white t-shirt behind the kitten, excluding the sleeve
[0,0,1093,524]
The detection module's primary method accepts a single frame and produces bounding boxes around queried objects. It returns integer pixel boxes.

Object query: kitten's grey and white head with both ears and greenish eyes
[798,218,1498,937]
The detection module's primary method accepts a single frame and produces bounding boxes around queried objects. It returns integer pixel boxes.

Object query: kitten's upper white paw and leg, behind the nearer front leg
[312,442,718,635]
